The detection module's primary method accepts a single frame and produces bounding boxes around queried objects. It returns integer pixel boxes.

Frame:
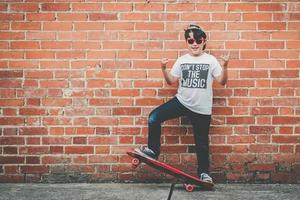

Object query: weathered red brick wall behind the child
[0,0,300,182]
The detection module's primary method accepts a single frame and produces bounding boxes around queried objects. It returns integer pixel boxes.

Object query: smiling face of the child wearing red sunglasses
[186,32,205,56]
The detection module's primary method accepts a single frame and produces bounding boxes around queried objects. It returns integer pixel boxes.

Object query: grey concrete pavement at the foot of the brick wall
[0,183,300,200]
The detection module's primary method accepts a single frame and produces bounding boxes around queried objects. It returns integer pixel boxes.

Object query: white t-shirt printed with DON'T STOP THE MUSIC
[171,53,222,115]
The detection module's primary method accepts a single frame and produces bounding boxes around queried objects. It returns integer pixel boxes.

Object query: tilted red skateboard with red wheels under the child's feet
[127,150,214,192]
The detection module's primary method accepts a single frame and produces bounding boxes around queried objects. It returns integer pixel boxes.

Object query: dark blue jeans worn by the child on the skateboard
[148,97,211,175]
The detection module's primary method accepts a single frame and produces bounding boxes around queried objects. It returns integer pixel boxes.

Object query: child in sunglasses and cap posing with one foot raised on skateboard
[136,24,228,182]
